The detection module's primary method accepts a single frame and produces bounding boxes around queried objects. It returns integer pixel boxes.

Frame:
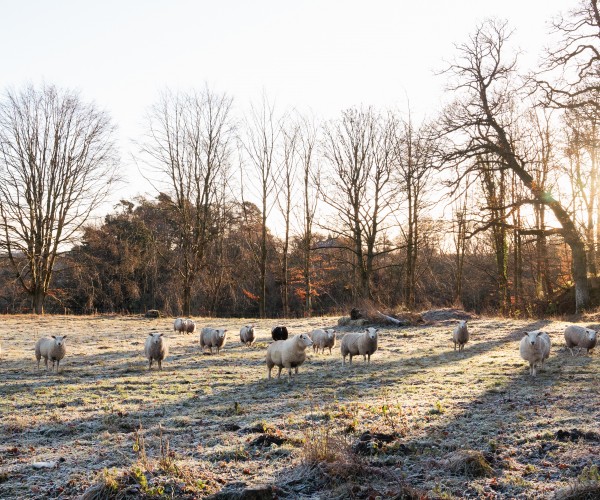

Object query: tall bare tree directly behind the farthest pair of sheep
[141,88,234,316]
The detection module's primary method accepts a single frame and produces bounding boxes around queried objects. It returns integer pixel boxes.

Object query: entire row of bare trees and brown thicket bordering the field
[0,1,600,317]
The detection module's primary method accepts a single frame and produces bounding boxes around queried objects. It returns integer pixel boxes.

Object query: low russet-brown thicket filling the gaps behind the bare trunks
[0,194,570,317]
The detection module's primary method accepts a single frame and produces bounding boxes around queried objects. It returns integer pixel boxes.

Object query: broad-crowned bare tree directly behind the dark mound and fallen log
[320,108,395,299]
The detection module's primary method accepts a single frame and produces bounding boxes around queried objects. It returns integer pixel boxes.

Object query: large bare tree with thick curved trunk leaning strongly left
[442,21,589,311]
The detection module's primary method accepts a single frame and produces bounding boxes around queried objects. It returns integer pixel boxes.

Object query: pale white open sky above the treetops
[0,0,576,207]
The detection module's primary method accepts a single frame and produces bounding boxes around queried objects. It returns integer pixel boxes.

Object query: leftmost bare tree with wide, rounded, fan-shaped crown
[0,85,117,314]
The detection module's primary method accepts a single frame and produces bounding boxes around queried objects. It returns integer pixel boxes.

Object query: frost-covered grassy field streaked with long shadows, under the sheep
[0,316,600,499]
